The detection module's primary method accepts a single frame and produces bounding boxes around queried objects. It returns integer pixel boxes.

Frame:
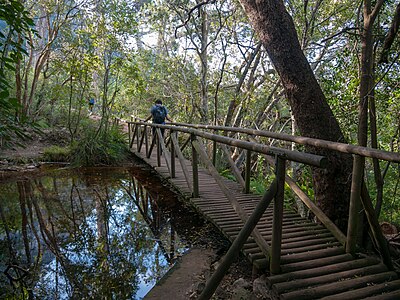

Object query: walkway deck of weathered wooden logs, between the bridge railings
[131,145,400,300]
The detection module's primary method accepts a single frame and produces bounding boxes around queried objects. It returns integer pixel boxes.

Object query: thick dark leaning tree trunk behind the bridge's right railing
[240,0,352,229]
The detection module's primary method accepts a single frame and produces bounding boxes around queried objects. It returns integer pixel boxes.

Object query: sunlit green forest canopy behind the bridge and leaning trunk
[0,0,400,222]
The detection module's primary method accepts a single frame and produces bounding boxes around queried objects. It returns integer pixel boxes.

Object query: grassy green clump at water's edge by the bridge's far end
[71,125,129,166]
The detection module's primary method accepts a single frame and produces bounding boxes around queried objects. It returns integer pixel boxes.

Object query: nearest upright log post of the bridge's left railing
[270,156,286,274]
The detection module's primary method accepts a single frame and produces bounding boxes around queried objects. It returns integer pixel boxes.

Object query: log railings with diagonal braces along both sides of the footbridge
[128,118,400,299]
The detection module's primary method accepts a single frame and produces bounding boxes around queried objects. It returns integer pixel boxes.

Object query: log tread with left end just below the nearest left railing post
[266,254,380,287]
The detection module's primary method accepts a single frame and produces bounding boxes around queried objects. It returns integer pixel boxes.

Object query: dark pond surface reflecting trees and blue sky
[0,169,186,299]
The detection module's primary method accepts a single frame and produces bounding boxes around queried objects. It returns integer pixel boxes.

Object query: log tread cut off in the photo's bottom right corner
[322,279,400,300]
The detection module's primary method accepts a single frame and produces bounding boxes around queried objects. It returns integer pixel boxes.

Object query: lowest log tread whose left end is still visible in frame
[280,272,397,300]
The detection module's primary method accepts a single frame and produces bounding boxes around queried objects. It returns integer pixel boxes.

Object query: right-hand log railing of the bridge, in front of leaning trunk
[165,123,400,269]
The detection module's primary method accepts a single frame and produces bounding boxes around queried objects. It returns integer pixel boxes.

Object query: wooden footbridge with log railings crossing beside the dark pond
[128,119,400,300]
